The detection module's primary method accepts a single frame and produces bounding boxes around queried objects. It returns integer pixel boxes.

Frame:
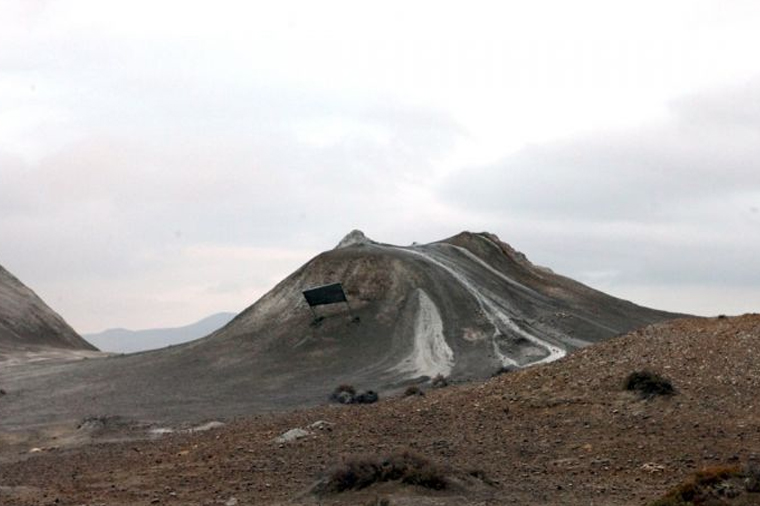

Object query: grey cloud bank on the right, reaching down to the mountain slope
[440,81,760,304]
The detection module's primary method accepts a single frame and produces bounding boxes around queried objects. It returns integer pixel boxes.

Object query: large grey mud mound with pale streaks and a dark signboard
[0,231,677,426]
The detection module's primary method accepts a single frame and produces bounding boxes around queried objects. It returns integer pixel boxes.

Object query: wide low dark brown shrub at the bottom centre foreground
[316,450,448,493]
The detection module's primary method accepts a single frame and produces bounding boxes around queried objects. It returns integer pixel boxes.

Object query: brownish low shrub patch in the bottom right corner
[649,465,760,506]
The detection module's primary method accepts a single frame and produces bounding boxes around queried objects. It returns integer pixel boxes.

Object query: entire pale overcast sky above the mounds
[0,0,760,333]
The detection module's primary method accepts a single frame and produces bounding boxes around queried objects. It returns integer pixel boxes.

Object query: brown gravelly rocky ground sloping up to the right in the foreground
[0,315,760,506]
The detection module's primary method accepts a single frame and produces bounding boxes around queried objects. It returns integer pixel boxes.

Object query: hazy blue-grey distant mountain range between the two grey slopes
[84,313,235,353]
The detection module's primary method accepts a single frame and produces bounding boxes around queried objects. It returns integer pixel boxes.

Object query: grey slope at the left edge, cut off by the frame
[0,266,96,355]
